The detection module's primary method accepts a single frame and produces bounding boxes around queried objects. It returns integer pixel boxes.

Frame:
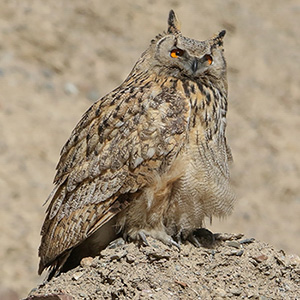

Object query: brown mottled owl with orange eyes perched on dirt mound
[39,10,235,279]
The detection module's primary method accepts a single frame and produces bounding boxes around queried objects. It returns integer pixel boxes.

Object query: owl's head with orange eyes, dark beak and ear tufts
[137,10,226,85]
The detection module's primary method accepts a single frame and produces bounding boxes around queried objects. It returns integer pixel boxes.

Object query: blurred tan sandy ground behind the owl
[0,0,300,297]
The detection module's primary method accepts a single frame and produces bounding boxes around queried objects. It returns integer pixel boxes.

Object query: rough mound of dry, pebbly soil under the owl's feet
[27,235,300,300]
